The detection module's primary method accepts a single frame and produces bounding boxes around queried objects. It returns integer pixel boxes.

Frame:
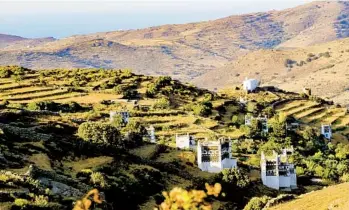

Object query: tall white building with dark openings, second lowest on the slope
[197,141,237,173]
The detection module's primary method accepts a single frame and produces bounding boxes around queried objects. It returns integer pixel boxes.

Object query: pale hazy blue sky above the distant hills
[0,0,310,38]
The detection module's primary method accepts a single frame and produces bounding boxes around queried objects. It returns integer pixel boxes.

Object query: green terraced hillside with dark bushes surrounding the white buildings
[0,66,349,210]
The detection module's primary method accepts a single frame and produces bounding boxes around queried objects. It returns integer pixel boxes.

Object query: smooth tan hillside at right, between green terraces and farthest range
[194,39,349,104]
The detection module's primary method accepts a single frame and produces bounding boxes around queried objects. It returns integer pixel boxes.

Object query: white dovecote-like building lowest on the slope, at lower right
[261,148,297,191]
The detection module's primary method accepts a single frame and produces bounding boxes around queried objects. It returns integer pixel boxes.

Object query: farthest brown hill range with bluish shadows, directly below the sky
[0,1,349,82]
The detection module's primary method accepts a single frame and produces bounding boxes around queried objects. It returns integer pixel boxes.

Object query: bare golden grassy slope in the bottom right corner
[268,183,349,210]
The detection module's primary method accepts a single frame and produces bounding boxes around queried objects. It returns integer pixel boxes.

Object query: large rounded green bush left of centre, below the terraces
[78,122,123,147]
